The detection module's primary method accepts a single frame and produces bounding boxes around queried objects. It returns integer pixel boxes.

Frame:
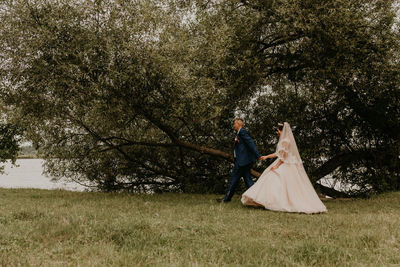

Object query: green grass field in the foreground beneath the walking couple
[0,189,400,266]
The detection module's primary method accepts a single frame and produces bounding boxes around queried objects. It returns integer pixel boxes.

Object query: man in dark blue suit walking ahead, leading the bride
[217,118,263,202]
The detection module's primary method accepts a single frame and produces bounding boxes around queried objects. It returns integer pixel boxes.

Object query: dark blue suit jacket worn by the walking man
[235,128,261,166]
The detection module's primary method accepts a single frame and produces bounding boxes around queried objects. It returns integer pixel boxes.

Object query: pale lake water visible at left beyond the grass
[0,159,86,191]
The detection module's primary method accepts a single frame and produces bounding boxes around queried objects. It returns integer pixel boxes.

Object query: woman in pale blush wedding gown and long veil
[242,122,327,213]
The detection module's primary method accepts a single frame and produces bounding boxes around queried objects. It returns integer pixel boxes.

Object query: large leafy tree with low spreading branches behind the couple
[0,0,400,196]
